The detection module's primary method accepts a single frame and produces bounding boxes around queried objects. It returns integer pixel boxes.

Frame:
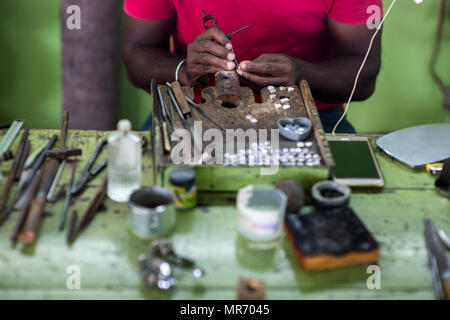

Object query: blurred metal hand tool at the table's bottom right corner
[425,219,450,300]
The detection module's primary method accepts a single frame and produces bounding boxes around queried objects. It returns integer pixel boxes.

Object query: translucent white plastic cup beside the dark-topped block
[236,185,287,243]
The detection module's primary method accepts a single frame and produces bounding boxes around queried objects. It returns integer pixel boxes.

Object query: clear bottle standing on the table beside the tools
[107,120,142,202]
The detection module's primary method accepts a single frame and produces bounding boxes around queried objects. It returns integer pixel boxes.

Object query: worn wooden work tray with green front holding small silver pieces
[151,81,334,191]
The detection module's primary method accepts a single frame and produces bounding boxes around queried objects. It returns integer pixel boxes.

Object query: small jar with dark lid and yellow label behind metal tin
[169,168,197,209]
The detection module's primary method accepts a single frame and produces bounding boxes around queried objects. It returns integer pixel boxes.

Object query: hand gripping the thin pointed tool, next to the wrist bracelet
[180,27,235,87]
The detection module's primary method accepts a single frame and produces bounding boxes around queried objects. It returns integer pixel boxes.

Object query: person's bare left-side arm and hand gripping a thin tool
[122,16,235,91]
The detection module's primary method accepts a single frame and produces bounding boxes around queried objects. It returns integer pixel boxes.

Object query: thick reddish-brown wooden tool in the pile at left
[19,159,59,244]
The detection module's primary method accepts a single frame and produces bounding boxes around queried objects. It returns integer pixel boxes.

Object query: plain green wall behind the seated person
[0,0,450,133]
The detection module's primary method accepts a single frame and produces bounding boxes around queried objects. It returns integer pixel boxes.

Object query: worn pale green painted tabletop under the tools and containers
[0,130,450,299]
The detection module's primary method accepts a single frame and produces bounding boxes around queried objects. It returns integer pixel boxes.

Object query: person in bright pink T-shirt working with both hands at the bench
[123,0,383,133]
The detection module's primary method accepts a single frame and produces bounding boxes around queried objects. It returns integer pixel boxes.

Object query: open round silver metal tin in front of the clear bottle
[127,187,176,239]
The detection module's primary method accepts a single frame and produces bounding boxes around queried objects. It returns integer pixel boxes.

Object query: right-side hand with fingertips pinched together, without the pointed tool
[237,53,300,87]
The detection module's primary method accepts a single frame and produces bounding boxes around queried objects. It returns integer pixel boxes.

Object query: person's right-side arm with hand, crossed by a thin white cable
[238,19,381,103]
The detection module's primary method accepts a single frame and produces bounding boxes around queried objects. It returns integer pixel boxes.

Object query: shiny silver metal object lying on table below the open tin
[138,239,205,291]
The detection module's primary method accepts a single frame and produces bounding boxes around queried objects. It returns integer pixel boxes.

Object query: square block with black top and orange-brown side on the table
[285,208,380,271]
